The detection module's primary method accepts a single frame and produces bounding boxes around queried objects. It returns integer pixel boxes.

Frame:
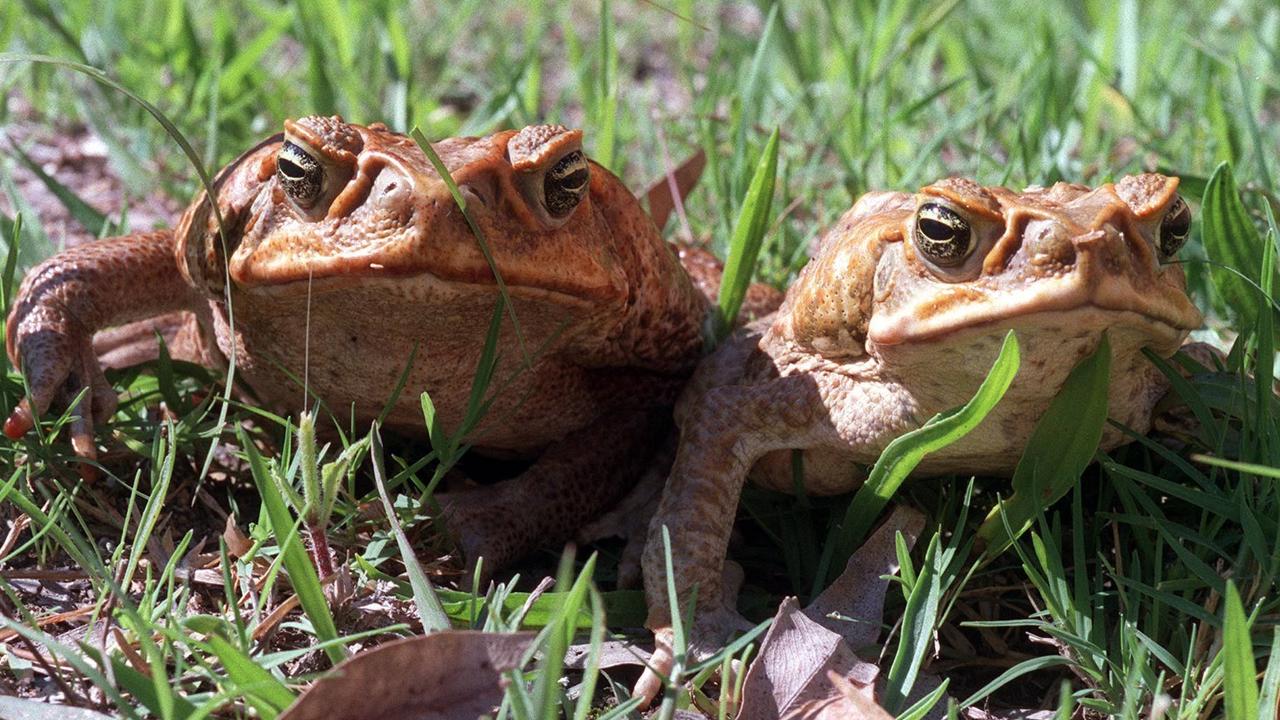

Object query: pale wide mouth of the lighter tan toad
[867,272,1202,348]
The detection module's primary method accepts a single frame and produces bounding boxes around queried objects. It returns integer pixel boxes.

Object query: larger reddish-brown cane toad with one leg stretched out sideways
[5,117,776,568]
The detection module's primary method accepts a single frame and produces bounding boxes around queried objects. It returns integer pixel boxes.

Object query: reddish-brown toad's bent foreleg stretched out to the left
[4,231,200,459]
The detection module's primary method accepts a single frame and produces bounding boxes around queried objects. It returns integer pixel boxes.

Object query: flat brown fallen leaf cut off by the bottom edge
[279,630,534,720]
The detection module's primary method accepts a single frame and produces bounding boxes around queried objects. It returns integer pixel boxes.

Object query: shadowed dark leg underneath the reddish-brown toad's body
[438,410,671,573]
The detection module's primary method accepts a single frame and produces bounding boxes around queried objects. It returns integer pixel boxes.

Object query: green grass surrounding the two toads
[0,0,1280,720]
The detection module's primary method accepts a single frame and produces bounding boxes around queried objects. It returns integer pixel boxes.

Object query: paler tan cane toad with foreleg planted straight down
[637,174,1201,697]
